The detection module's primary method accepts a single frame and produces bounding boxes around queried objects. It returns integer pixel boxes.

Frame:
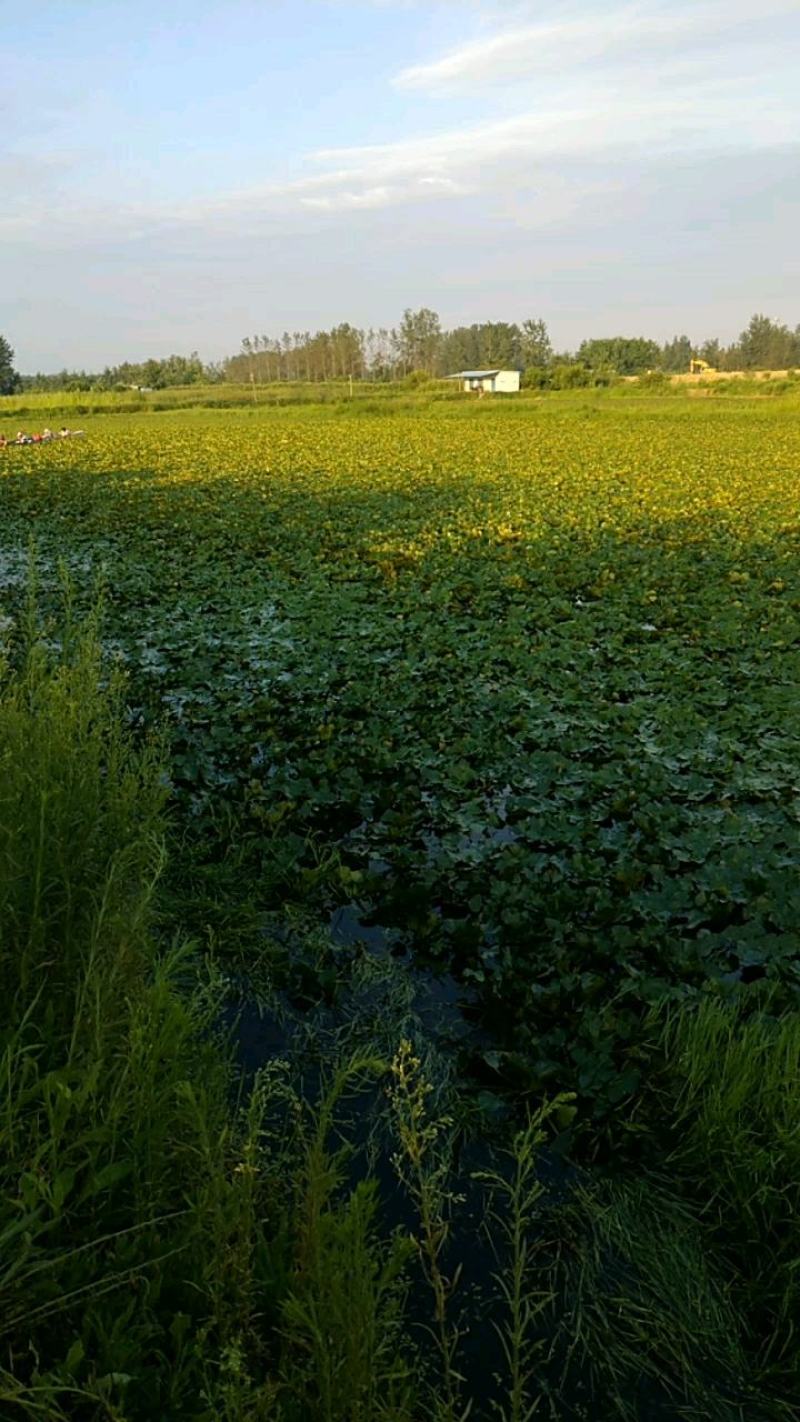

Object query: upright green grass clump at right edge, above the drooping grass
[661,1000,800,1391]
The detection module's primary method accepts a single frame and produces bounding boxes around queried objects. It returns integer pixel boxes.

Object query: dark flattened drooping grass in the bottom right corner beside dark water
[553,1179,767,1422]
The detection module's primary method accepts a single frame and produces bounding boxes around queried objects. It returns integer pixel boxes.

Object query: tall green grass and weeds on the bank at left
[0,610,277,1418]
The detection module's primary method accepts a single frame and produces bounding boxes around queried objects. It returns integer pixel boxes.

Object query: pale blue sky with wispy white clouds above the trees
[0,0,800,373]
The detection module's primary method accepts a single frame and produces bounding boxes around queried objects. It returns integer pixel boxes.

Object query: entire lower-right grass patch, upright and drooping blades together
[554,997,800,1422]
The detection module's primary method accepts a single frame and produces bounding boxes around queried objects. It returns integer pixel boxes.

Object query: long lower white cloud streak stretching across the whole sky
[0,84,797,246]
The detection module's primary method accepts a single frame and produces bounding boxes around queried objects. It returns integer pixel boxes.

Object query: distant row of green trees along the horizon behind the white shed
[6,307,800,394]
